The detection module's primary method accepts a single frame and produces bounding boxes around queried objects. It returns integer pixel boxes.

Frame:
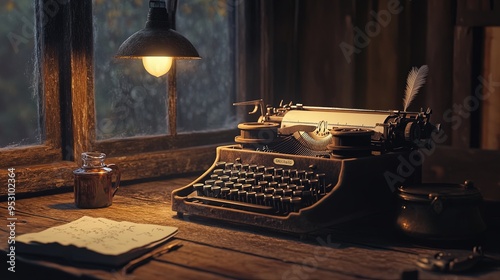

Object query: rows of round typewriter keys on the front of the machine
[189,162,333,215]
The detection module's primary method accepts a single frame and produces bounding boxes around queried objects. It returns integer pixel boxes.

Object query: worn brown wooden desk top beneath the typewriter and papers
[0,177,500,279]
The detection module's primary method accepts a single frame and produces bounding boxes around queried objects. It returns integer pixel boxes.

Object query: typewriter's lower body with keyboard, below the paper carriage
[172,145,421,234]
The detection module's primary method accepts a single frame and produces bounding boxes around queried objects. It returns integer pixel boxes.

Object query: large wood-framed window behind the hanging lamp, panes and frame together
[0,0,250,196]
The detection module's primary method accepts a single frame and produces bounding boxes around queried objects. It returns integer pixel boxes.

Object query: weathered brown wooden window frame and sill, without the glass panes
[0,0,261,197]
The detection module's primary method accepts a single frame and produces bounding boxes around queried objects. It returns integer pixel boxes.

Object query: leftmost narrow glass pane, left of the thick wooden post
[0,0,41,148]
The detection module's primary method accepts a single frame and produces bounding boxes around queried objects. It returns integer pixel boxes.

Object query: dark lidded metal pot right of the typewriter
[396,181,486,240]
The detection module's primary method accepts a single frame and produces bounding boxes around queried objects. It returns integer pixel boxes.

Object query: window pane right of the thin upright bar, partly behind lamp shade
[176,0,237,132]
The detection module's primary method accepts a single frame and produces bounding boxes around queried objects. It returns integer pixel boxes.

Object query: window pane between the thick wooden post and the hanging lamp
[93,0,168,139]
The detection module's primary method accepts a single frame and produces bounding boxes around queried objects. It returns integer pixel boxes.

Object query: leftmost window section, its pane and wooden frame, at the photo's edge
[0,0,62,174]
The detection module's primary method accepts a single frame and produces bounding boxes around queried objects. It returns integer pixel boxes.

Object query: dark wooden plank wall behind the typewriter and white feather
[265,0,500,148]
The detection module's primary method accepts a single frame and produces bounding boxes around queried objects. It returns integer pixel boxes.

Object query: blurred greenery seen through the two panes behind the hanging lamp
[93,0,239,140]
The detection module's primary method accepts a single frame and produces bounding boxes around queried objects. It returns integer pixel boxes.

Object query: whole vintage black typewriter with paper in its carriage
[172,100,437,234]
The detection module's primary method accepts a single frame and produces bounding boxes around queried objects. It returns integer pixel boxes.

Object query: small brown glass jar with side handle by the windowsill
[73,152,121,208]
